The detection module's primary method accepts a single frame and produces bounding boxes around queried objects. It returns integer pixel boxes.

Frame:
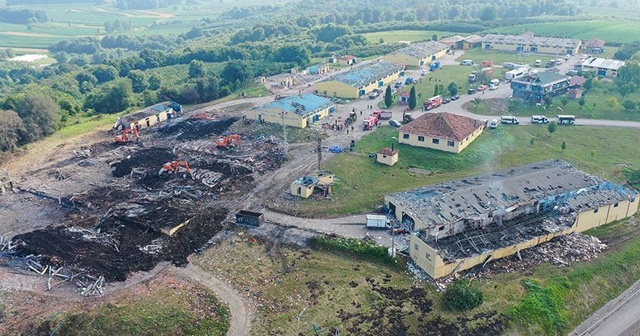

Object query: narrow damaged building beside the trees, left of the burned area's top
[113,101,182,130]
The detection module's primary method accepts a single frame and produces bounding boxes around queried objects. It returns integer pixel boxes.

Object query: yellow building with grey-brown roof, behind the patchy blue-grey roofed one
[383,41,449,66]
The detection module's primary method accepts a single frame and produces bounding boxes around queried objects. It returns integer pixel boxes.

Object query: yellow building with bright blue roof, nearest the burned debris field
[246,94,335,128]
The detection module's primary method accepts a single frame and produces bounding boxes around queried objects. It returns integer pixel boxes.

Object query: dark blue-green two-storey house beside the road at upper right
[511,71,571,103]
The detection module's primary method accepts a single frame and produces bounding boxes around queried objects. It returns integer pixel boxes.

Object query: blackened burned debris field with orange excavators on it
[2,117,286,288]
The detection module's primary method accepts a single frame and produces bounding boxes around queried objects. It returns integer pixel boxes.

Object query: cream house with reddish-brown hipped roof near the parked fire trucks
[398,112,485,153]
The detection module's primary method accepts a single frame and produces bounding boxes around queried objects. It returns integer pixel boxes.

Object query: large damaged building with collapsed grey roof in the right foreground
[385,160,638,278]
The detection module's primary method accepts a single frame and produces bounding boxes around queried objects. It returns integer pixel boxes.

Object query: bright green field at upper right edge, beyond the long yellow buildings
[482,20,640,43]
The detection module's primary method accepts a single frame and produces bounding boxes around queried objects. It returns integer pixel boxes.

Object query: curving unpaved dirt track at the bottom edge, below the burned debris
[171,263,253,336]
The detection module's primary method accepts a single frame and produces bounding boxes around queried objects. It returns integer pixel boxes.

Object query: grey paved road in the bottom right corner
[569,280,640,336]
